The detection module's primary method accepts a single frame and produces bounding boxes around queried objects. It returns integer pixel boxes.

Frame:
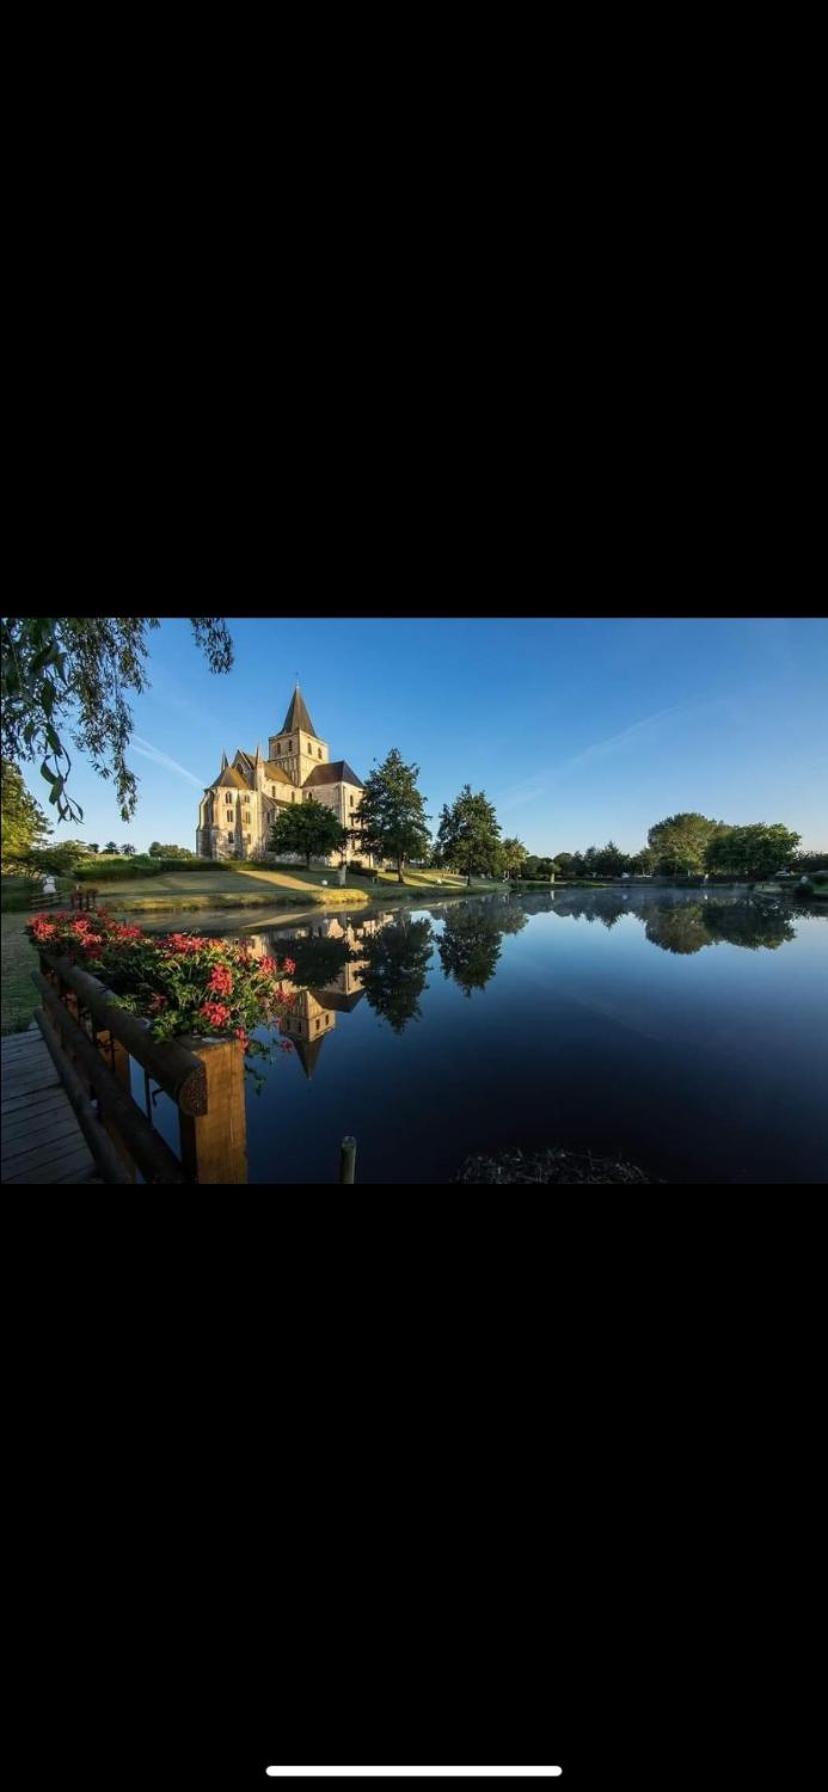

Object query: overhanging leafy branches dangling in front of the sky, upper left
[0,616,233,821]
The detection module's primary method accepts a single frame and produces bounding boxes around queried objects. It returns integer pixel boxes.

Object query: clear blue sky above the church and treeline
[23,616,828,853]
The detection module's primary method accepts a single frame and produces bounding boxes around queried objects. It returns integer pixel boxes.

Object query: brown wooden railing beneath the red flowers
[32,948,247,1183]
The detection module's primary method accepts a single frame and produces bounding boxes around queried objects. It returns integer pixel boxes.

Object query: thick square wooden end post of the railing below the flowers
[179,1039,247,1183]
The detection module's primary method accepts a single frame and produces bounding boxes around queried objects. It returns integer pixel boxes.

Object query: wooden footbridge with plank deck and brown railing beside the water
[0,948,247,1186]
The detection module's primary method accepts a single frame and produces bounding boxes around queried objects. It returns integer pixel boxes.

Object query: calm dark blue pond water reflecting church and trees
[136,889,828,1185]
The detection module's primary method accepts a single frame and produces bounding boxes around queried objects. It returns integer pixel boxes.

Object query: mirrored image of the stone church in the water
[247,914,394,1077]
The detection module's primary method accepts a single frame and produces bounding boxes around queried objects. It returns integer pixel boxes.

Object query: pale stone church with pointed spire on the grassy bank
[195,686,373,866]
